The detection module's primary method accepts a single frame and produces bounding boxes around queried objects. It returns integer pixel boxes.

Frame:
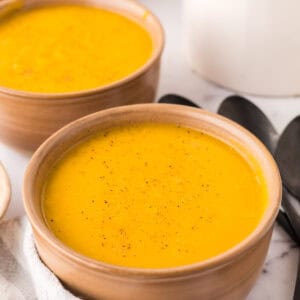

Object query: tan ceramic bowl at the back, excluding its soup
[0,0,164,150]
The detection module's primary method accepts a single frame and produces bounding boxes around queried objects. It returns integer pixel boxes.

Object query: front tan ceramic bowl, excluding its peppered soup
[23,104,281,300]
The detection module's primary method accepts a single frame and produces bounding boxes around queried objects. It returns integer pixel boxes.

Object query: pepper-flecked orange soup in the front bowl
[43,123,267,268]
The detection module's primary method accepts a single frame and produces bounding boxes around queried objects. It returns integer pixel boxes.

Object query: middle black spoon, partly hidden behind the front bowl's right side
[218,96,300,244]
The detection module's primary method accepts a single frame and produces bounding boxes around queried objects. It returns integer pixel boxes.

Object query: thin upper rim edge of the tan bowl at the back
[0,0,165,101]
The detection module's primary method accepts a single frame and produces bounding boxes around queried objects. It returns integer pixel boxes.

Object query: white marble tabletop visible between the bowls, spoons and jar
[0,0,300,300]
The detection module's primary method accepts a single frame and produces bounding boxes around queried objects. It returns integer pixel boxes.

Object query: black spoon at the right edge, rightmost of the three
[275,116,300,300]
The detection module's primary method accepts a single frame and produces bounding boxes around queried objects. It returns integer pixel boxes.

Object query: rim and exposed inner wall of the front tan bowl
[24,104,281,274]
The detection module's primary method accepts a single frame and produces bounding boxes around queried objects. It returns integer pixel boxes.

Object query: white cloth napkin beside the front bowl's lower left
[0,217,79,300]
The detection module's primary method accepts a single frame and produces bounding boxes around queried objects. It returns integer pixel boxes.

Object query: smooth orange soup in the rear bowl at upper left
[0,5,152,93]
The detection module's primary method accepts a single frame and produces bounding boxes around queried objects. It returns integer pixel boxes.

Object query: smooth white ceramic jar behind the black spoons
[183,0,300,96]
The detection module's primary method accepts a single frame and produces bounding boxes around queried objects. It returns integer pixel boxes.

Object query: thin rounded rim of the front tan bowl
[23,103,282,279]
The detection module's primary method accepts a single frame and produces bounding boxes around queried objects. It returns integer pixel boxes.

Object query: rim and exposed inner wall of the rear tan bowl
[0,0,164,99]
